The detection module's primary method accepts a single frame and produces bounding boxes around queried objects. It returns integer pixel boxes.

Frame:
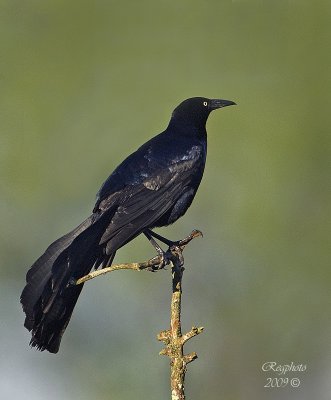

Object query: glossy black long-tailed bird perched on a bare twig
[21,97,235,353]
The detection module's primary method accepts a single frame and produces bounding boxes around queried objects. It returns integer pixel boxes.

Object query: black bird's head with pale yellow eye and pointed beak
[170,97,236,133]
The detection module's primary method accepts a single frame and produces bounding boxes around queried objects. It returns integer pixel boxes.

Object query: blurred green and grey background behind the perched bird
[0,0,331,400]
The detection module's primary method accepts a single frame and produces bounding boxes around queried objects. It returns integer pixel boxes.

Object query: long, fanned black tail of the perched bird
[21,214,113,353]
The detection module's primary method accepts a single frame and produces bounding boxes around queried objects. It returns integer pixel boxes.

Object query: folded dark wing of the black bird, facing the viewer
[99,160,200,254]
